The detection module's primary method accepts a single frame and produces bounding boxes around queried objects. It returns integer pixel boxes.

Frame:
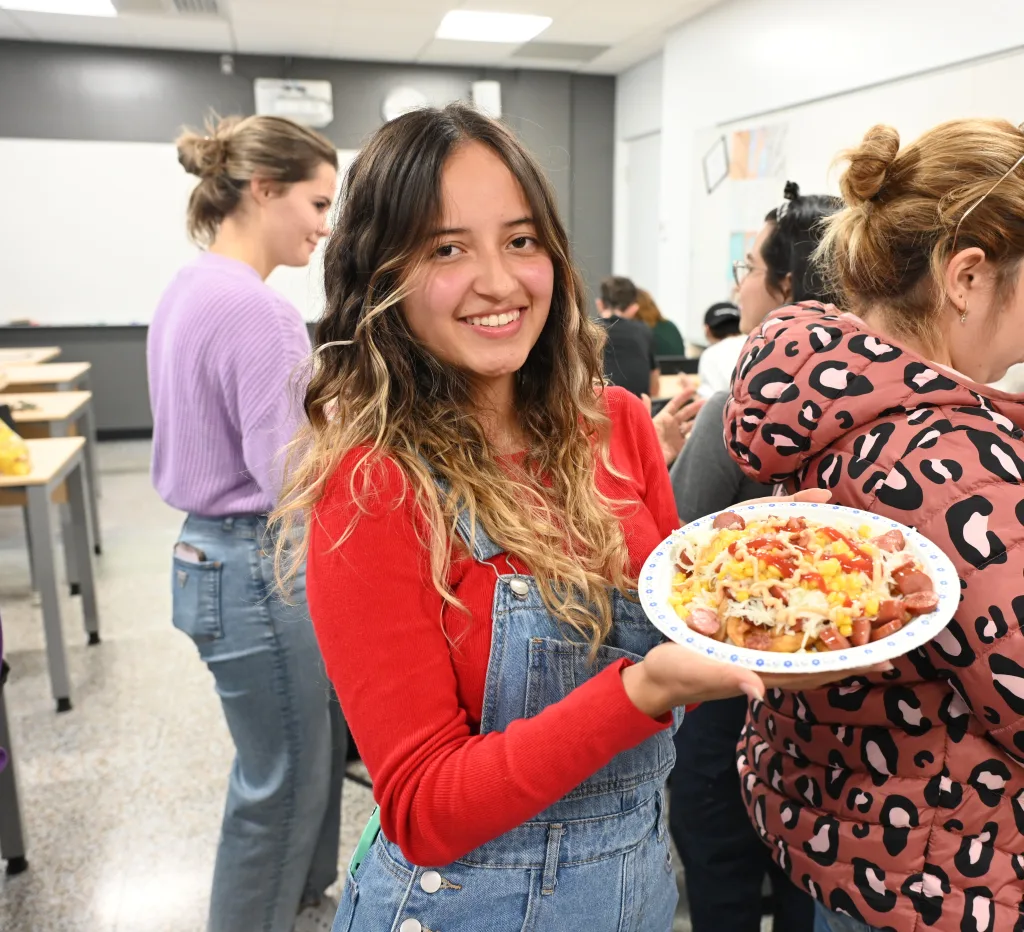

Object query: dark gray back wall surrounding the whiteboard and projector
[0,41,614,432]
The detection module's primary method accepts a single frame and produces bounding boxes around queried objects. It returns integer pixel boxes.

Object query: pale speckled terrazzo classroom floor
[0,441,770,932]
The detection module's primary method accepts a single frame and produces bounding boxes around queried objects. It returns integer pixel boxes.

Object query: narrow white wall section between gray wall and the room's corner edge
[611,55,663,297]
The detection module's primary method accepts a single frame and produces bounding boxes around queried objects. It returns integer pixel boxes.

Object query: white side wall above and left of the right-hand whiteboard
[658,0,1024,340]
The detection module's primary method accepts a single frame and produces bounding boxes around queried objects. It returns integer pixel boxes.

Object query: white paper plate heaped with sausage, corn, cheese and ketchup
[640,501,961,673]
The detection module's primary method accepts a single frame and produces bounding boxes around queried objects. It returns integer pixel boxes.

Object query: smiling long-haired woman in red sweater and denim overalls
[282,104,835,932]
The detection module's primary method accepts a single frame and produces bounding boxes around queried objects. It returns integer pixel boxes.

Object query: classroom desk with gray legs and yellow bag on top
[0,437,99,712]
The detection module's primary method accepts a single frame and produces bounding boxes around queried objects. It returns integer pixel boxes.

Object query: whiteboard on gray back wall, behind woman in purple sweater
[0,139,355,326]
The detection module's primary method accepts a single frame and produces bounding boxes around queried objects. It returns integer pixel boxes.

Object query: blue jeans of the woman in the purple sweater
[172,515,347,932]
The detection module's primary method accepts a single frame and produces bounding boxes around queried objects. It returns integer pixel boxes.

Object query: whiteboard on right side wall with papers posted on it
[685,44,1024,342]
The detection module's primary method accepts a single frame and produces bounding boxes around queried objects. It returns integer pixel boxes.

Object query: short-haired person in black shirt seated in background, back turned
[597,276,662,397]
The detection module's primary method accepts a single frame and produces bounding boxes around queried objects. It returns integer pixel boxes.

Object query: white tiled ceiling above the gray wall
[0,0,722,74]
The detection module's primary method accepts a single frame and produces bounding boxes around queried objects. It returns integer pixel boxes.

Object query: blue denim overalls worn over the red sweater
[332,514,678,932]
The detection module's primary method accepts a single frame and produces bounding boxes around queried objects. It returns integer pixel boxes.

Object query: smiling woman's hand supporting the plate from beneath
[623,643,892,718]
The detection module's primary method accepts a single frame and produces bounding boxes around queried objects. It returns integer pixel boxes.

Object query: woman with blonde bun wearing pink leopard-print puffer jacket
[725,120,1024,932]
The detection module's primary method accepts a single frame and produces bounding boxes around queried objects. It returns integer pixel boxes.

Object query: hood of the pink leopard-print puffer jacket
[725,302,1024,482]
